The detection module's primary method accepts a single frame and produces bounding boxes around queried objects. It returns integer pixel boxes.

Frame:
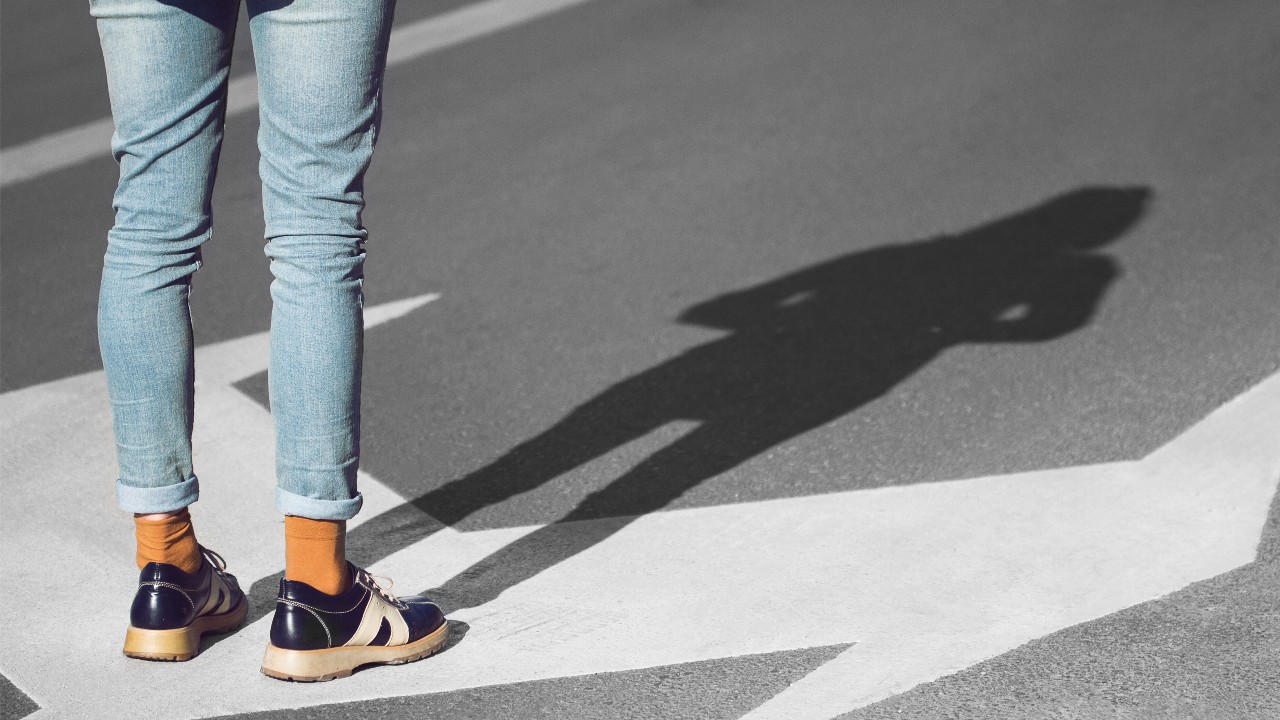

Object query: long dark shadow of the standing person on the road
[325,187,1151,611]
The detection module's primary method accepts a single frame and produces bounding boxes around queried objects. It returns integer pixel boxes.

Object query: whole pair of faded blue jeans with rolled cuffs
[90,0,394,520]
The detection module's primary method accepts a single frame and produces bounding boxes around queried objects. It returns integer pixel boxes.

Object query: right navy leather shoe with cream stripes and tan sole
[262,562,449,682]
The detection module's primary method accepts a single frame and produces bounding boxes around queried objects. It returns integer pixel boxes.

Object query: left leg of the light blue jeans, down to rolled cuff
[90,0,237,548]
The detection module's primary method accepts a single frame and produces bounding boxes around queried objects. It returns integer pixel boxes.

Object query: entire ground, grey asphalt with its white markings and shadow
[0,0,1280,720]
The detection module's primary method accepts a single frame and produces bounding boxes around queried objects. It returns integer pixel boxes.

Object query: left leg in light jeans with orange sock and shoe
[90,0,247,660]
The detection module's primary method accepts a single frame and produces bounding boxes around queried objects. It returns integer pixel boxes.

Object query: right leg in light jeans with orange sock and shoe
[248,0,448,680]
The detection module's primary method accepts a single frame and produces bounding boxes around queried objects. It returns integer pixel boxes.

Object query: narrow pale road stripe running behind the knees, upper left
[0,0,588,187]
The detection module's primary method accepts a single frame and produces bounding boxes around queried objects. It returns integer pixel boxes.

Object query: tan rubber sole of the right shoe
[262,621,449,683]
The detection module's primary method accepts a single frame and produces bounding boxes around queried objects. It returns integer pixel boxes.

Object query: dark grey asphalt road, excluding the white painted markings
[0,0,1280,717]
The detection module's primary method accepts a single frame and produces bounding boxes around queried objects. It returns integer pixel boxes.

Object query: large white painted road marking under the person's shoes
[0,293,1280,719]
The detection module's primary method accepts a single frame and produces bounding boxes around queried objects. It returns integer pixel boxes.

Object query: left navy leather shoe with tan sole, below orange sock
[124,547,248,661]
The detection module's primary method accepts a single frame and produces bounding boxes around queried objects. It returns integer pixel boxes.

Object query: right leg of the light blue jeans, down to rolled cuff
[248,0,393,520]
